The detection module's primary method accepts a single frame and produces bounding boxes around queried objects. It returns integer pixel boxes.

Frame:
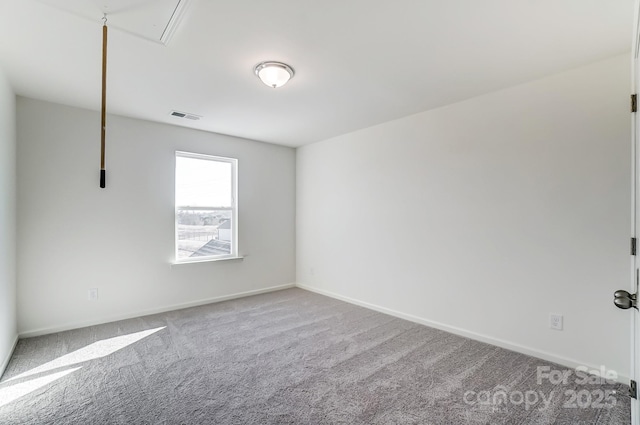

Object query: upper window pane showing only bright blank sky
[176,156,232,207]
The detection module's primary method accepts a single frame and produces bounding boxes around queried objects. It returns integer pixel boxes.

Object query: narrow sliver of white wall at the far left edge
[0,63,18,376]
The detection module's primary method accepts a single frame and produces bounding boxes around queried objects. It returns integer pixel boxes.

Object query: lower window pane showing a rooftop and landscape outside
[177,209,233,260]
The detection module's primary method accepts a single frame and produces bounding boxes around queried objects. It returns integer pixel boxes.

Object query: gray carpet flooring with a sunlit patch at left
[0,289,630,425]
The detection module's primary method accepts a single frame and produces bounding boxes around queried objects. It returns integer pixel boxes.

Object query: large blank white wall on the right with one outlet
[297,55,631,376]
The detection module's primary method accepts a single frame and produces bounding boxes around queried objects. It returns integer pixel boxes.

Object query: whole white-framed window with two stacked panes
[176,152,238,262]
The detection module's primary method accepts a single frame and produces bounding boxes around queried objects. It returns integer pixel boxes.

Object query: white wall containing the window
[17,97,295,335]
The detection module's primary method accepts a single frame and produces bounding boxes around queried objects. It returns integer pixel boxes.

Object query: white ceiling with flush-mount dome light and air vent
[0,0,633,146]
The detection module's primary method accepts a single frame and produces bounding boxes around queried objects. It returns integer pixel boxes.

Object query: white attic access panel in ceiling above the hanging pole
[38,0,189,45]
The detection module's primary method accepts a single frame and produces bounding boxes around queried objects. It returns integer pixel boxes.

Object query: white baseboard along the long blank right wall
[296,283,630,385]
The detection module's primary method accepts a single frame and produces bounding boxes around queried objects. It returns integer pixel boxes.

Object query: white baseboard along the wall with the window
[19,283,296,338]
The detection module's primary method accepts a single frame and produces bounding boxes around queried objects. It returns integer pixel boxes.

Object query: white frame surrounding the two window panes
[173,151,240,264]
